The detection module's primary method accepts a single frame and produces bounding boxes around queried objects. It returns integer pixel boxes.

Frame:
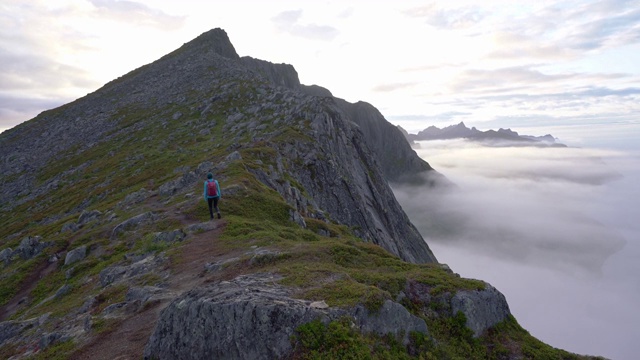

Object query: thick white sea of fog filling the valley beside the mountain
[394,124,640,360]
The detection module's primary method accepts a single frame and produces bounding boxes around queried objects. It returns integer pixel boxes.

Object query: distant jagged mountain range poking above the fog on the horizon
[399,122,566,147]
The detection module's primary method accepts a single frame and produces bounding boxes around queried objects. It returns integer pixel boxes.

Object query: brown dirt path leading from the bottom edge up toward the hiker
[71,200,226,360]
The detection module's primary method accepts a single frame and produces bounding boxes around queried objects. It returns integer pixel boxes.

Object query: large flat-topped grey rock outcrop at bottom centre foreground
[144,274,427,360]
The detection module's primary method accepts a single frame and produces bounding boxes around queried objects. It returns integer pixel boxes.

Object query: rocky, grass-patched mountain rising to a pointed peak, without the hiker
[0,29,600,359]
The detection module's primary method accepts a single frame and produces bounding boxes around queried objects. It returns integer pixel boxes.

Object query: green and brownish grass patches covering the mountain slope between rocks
[0,80,604,359]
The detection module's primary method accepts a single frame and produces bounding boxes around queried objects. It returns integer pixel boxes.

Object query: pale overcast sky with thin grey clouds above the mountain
[0,0,640,131]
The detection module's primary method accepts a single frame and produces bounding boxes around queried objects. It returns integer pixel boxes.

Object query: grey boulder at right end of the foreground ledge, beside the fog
[451,284,511,337]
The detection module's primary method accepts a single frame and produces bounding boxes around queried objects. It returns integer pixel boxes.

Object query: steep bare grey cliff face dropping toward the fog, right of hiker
[242,94,437,263]
